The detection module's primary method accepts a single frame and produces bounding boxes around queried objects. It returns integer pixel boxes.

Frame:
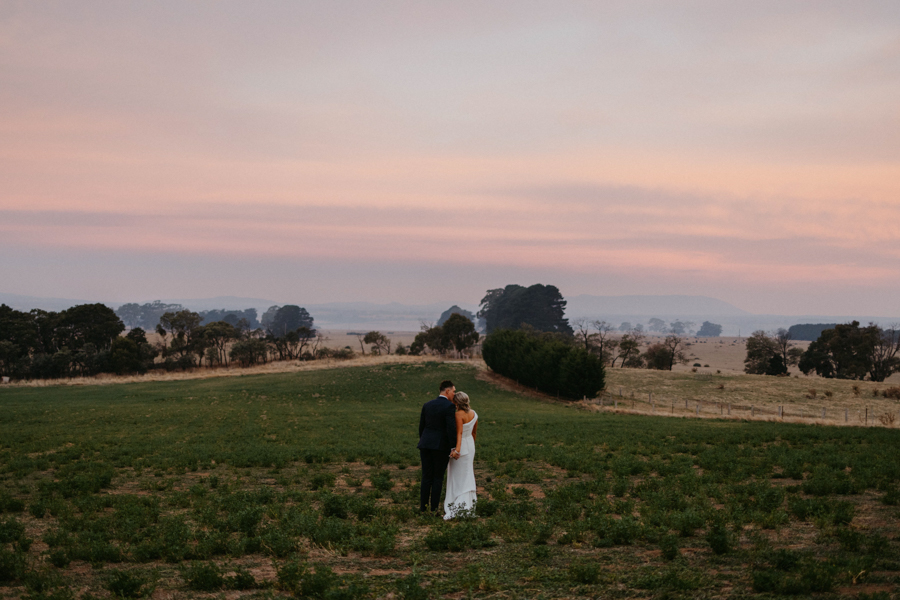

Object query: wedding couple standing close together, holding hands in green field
[418,381,478,519]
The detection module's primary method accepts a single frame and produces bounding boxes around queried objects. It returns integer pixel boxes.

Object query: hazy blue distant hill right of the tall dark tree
[566,294,751,320]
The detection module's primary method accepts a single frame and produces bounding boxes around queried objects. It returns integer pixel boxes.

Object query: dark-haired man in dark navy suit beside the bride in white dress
[418,380,456,514]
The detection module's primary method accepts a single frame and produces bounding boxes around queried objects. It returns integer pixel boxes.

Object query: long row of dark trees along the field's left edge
[0,301,344,379]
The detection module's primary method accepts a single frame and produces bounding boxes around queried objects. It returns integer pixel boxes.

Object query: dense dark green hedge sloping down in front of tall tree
[481,330,605,399]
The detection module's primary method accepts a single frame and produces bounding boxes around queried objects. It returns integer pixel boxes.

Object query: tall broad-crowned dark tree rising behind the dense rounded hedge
[477,284,573,336]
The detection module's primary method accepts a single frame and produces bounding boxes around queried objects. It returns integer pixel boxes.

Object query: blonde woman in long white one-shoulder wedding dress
[444,392,478,520]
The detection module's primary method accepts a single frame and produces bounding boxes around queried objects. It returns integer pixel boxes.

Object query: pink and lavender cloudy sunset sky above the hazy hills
[0,0,900,316]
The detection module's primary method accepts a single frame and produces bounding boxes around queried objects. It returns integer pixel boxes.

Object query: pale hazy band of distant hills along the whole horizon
[0,293,900,336]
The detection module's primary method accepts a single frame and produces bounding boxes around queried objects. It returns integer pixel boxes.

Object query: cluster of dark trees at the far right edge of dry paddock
[744,321,900,381]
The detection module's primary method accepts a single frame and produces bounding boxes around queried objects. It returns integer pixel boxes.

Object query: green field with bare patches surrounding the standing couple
[0,363,900,599]
